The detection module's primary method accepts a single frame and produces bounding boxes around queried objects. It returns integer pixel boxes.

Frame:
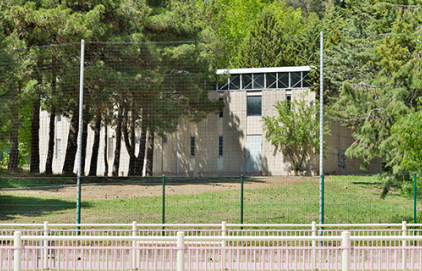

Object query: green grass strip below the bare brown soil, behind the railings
[0,176,422,223]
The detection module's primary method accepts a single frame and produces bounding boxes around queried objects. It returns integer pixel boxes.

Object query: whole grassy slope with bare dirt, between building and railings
[0,176,422,223]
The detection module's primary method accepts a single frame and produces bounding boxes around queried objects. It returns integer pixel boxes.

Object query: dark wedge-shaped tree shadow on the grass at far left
[0,195,90,221]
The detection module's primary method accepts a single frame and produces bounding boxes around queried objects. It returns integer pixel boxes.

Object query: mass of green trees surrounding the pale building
[0,0,422,178]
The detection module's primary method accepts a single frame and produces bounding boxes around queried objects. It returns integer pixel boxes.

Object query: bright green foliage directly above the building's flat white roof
[198,0,319,68]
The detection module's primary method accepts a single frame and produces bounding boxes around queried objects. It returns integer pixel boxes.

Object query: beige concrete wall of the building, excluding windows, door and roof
[40,76,382,177]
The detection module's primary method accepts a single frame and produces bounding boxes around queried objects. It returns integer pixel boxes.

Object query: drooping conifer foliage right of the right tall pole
[327,1,420,173]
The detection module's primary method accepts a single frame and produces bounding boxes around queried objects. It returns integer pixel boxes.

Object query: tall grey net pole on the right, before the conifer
[319,31,324,227]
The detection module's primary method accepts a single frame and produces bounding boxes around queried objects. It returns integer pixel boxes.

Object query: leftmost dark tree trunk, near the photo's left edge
[7,82,22,172]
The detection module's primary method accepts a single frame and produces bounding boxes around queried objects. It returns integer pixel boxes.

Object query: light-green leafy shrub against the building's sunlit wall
[262,92,330,173]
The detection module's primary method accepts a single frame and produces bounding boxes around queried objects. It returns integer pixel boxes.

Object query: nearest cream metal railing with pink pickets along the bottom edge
[0,231,422,271]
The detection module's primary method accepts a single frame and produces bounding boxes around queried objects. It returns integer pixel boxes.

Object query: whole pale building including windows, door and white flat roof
[41,66,382,177]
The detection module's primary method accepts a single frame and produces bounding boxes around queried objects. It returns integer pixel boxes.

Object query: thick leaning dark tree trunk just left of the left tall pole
[62,114,79,174]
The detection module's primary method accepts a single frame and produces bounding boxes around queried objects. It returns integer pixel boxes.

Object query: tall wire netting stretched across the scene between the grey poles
[0,35,422,223]
